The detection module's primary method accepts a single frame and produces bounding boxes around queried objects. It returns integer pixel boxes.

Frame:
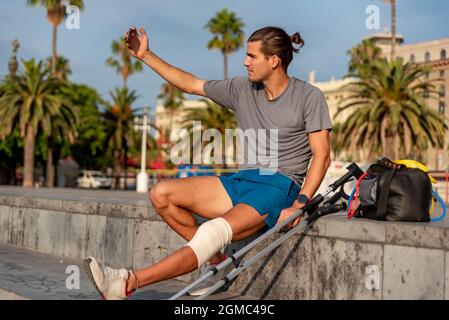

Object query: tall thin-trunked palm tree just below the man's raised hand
[106,39,142,88]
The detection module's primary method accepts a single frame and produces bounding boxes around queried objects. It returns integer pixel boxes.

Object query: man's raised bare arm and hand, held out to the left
[125,27,205,96]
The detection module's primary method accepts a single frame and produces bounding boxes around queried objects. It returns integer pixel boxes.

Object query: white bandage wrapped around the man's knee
[186,218,232,268]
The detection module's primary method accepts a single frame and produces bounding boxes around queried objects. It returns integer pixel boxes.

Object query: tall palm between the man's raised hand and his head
[205,8,245,79]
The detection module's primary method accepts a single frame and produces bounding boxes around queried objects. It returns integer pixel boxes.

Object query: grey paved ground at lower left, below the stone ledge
[0,244,254,300]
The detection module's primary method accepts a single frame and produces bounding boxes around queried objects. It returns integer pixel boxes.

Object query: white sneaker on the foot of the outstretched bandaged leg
[84,257,132,300]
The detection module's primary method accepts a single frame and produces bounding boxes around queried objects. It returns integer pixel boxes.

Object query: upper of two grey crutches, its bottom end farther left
[169,163,363,300]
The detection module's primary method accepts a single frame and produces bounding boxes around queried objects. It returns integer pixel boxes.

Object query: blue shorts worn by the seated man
[218,169,300,228]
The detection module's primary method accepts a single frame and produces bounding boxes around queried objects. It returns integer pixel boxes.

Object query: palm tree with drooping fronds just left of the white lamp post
[103,87,137,188]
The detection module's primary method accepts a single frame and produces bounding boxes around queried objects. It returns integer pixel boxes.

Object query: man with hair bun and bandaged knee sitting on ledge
[85,27,332,299]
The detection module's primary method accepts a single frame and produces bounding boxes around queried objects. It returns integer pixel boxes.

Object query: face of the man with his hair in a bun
[243,41,277,82]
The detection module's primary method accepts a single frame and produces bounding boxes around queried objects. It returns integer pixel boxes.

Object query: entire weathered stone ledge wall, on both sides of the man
[0,196,449,299]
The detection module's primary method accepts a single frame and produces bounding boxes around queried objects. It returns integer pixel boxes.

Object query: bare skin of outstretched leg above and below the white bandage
[128,204,266,291]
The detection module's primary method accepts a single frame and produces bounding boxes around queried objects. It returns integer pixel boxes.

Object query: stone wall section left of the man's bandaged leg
[0,196,197,282]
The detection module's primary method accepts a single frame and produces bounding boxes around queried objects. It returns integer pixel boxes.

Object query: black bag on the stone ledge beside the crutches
[356,158,432,222]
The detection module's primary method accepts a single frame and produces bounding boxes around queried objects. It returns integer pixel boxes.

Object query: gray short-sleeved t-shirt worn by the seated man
[204,77,332,185]
